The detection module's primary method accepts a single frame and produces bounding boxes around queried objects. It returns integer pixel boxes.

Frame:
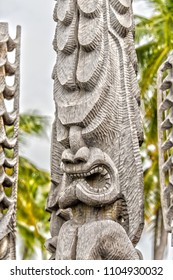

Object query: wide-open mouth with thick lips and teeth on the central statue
[59,148,120,208]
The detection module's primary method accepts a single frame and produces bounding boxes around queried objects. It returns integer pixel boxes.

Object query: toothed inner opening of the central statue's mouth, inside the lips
[68,166,111,193]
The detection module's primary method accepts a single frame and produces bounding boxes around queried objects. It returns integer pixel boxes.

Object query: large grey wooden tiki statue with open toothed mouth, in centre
[46,0,143,260]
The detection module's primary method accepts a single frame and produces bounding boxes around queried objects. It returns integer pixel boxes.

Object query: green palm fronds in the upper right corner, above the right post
[136,0,173,95]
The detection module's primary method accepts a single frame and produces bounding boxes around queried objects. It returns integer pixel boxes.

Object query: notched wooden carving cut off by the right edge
[157,56,173,246]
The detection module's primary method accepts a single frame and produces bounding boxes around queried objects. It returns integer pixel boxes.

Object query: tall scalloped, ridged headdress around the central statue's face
[48,0,143,258]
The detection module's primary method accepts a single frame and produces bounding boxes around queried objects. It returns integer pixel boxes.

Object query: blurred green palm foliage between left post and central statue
[17,113,50,259]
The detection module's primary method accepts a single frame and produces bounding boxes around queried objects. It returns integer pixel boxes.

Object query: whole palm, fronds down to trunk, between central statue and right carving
[136,0,173,259]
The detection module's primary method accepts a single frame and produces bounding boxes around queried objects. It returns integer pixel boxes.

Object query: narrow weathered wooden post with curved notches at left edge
[0,23,20,259]
